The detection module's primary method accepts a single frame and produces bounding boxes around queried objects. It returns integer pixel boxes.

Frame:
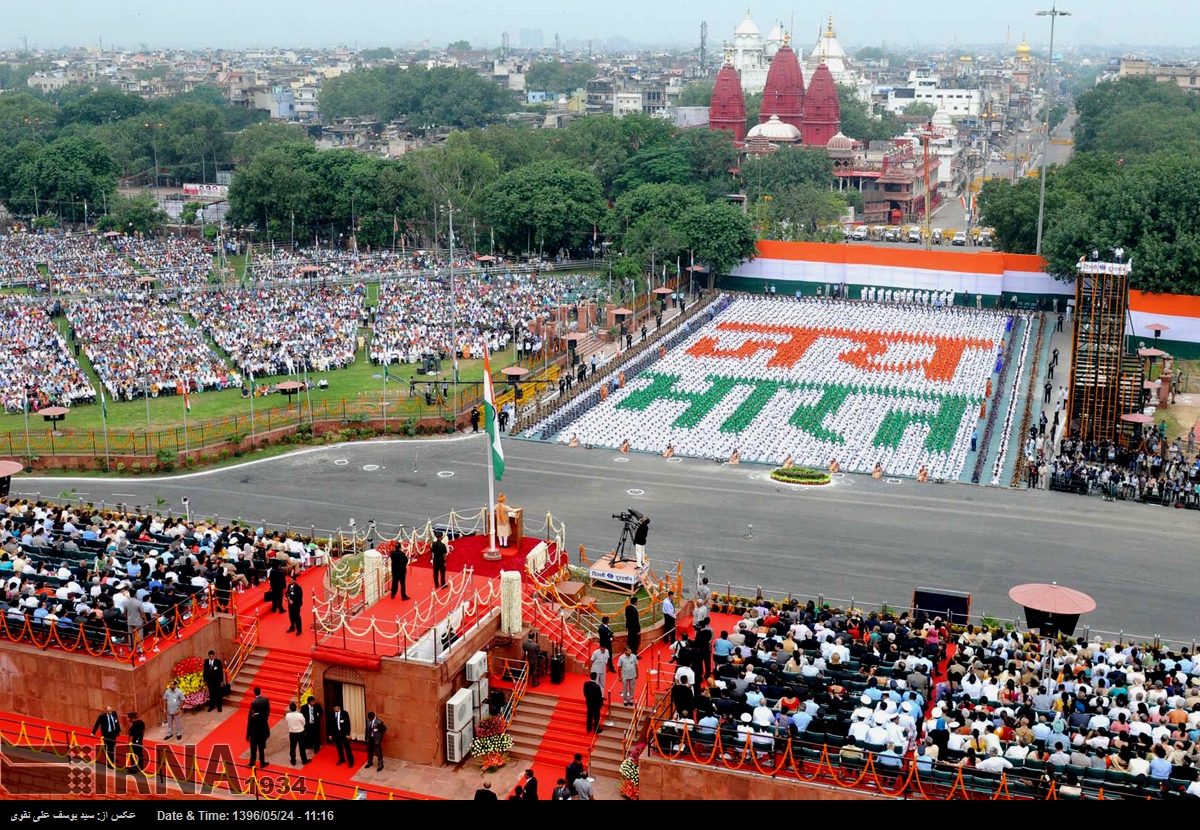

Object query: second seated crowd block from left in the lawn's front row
[67,300,242,401]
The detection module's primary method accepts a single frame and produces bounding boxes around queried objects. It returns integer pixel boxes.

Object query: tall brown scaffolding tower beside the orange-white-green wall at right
[1067,260,1142,441]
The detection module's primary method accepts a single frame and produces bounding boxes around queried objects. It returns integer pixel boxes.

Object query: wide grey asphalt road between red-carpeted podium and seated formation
[21,435,1200,640]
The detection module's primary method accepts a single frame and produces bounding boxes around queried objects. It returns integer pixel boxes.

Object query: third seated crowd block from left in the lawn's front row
[185,285,364,377]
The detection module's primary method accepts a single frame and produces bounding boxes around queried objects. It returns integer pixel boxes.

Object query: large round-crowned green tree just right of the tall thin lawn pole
[484,162,605,253]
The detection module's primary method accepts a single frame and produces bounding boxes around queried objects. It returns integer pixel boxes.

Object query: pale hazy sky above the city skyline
[11,0,1200,50]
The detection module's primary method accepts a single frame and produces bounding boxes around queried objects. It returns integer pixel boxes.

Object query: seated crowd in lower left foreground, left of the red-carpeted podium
[0,499,323,650]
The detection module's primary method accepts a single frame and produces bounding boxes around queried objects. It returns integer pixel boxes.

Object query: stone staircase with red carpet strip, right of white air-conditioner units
[509,691,634,778]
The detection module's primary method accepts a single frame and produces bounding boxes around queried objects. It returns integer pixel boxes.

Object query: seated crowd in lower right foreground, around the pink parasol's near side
[652,590,1200,799]
